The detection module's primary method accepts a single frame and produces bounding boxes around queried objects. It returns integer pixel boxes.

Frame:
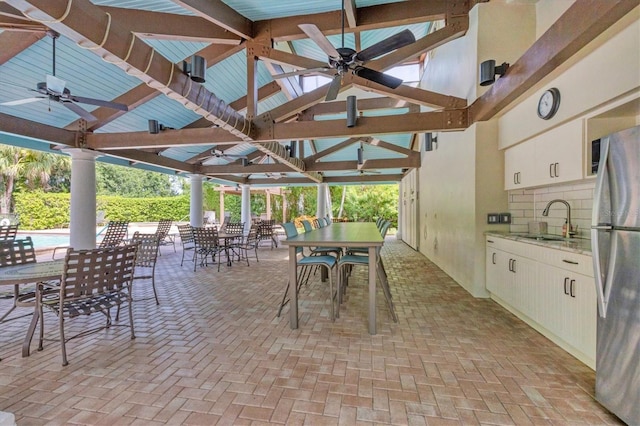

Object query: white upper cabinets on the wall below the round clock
[505,120,584,189]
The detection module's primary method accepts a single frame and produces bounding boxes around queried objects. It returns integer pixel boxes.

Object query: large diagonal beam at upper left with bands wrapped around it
[5,0,251,140]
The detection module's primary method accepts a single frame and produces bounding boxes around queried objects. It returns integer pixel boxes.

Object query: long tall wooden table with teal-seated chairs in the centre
[282,222,384,334]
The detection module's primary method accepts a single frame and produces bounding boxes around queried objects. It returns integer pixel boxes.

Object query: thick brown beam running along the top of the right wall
[469,0,638,124]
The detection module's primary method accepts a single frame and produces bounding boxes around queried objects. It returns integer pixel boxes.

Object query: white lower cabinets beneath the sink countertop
[486,236,597,369]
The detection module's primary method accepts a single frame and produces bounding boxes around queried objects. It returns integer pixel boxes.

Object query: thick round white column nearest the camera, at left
[63,148,100,250]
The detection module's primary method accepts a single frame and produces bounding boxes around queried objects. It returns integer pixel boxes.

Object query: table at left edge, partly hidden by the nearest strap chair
[0,259,64,357]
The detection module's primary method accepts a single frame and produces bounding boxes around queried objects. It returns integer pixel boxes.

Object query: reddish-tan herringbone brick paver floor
[0,237,618,425]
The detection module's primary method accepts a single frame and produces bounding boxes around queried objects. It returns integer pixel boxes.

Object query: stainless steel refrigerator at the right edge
[591,122,640,425]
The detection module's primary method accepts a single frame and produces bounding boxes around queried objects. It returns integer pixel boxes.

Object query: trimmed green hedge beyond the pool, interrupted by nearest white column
[14,191,189,230]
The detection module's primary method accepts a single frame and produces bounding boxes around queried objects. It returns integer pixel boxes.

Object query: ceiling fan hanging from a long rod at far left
[0,30,129,121]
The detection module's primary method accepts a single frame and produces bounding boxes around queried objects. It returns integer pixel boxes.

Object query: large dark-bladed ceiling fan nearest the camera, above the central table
[274,0,416,101]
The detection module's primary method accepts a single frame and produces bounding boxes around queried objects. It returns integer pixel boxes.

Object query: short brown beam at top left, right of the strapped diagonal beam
[100,6,242,45]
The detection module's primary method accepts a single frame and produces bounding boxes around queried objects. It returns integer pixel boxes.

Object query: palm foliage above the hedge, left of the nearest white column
[0,145,69,213]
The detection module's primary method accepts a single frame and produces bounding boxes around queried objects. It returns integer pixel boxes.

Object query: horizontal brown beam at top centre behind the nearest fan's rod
[254,0,450,41]
